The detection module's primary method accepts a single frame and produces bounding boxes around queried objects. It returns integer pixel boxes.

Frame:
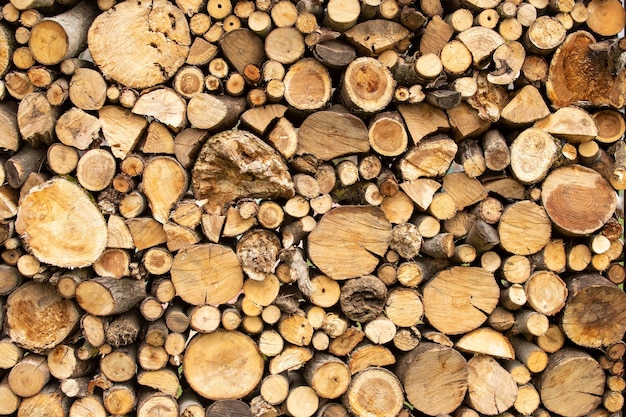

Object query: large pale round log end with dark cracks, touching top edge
[88,0,191,88]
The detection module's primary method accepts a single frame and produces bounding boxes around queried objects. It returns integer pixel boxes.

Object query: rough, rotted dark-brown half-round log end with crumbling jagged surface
[191,130,294,214]
